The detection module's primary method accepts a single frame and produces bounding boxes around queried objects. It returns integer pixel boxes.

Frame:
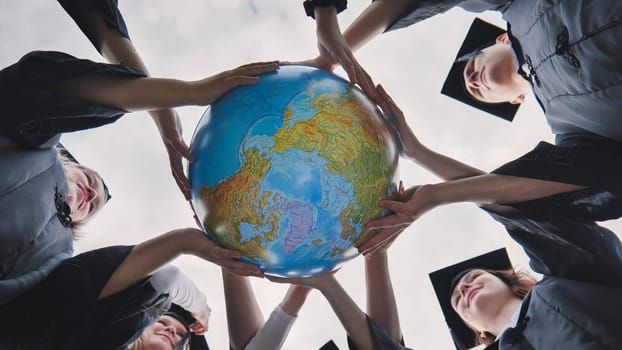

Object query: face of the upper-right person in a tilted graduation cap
[463,36,530,104]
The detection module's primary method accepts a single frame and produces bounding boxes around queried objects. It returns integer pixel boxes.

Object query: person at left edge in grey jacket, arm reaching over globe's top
[0,6,277,304]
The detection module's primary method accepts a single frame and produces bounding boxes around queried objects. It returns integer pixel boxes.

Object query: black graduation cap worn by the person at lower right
[430,248,512,350]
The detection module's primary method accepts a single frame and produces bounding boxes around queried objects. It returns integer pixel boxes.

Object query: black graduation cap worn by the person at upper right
[441,18,520,121]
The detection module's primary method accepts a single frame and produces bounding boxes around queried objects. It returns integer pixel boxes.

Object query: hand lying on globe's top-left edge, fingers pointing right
[190,61,279,105]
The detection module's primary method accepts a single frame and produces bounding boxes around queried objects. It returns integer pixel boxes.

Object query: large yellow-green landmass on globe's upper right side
[270,89,395,245]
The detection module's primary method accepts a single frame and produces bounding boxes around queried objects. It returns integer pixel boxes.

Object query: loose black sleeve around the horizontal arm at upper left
[0,51,145,147]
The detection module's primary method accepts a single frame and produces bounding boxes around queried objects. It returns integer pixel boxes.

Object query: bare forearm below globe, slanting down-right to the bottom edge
[318,276,374,350]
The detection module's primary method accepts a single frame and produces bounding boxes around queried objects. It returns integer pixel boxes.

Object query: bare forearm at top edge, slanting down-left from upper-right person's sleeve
[343,0,418,51]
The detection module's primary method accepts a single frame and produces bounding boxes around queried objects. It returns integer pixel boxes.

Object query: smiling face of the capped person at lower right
[451,270,517,330]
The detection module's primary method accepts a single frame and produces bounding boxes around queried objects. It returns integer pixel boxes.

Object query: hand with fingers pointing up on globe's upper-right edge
[376,85,423,159]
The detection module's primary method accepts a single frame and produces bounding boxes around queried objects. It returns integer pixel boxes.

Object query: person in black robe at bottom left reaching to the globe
[0,228,263,350]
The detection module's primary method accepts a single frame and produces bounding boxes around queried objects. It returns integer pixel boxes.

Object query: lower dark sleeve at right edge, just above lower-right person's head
[489,199,622,286]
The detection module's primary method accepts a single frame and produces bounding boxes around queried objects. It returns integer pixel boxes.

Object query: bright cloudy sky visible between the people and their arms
[0,0,622,350]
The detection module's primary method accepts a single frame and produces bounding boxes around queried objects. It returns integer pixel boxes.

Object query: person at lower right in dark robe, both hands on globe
[360,87,622,350]
